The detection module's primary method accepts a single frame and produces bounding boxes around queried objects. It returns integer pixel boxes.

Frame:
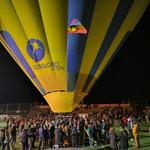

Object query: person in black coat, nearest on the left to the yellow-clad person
[119,128,129,150]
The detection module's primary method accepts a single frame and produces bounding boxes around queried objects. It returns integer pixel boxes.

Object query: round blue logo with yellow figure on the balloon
[26,39,45,62]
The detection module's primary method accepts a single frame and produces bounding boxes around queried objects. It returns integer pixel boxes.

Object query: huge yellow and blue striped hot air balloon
[0,0,150,112]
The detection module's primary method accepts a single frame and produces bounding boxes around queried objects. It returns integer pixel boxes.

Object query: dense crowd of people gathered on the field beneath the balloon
[0,107,150,150]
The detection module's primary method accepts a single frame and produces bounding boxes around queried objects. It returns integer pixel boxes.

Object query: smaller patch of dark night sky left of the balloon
[0,42,42,102]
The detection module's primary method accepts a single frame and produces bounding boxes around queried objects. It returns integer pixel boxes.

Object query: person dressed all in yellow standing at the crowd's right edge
[132,121,140,148]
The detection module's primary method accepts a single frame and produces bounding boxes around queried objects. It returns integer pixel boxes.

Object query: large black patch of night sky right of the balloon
[85,5,150,103]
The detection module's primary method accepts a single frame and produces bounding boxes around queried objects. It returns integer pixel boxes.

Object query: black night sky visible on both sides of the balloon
[0,6,150,103]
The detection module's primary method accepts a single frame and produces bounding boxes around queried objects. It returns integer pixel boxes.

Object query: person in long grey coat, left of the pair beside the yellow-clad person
[109,127,117,150]
